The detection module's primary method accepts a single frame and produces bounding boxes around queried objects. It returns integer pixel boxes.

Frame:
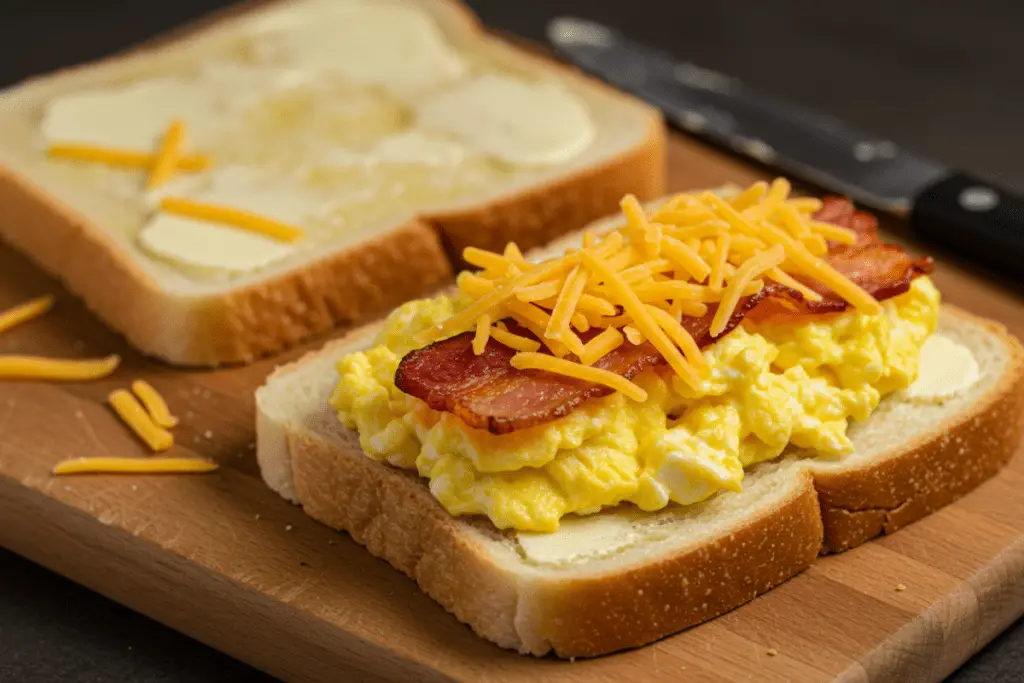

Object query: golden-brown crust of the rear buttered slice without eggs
[0,0,667,367]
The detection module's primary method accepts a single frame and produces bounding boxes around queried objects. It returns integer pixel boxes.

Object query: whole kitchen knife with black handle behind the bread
[548,16,1024,280]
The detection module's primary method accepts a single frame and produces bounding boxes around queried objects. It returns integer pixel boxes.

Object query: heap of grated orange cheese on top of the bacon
[416,178,882,401]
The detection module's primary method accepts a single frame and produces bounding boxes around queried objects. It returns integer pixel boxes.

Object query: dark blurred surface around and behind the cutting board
[0,0,1024,683]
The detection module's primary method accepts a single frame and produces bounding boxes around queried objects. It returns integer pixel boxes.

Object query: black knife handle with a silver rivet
[910,172,1024,280]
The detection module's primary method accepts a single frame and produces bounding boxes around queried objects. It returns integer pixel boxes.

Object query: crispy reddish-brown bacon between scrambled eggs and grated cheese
[394,197,934,434]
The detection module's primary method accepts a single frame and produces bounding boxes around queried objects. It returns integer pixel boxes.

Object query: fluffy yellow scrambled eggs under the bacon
[331,278,939,531]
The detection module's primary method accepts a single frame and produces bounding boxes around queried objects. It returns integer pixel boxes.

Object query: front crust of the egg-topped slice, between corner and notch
[519,470,821,657]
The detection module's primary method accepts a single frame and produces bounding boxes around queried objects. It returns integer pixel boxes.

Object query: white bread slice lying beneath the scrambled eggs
[256,306,1024,657]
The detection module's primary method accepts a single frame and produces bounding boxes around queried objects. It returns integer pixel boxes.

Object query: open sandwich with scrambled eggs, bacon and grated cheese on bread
[257,179,1024,656]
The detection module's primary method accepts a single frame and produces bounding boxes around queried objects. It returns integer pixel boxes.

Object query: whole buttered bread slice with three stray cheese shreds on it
[0,0,665,366]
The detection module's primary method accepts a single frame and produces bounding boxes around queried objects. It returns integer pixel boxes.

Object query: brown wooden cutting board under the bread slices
[0,138,1024,683]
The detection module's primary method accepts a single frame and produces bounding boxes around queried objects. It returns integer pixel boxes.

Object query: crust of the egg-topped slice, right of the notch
[814,304,1024,553]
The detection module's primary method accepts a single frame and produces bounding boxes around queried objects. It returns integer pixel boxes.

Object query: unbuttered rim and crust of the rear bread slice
[0,0,665,366]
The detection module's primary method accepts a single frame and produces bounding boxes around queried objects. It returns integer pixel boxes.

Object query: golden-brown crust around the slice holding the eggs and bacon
[260,305,1024,657]
